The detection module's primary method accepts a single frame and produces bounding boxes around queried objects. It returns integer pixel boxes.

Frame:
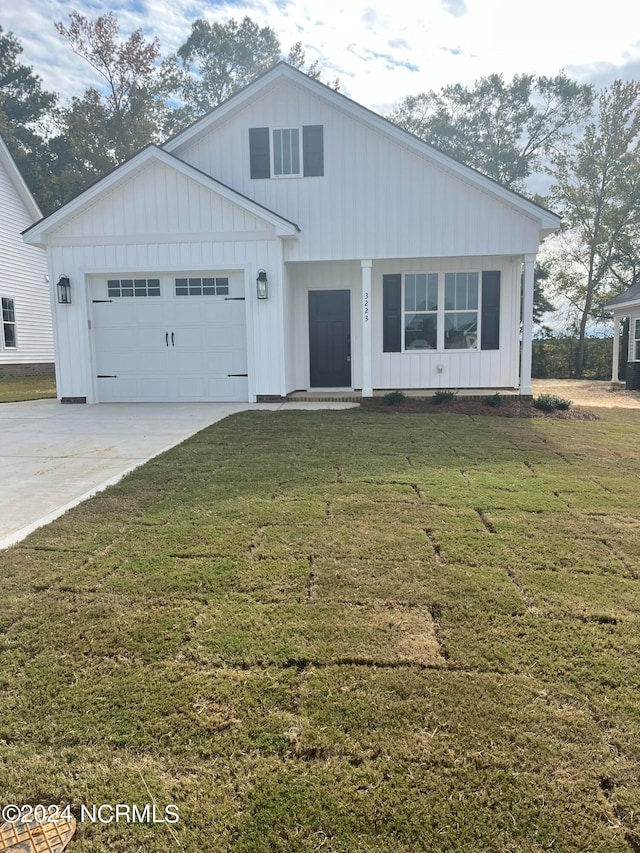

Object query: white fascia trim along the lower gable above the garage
[22,145,299,247]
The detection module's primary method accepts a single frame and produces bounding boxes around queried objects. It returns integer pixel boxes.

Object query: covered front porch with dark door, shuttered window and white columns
[283,254,535,400]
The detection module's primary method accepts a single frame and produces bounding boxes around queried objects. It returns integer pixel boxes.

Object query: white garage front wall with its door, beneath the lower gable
[42,156,284,402]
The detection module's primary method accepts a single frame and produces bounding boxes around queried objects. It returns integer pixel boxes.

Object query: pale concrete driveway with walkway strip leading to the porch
[0,400,350,549]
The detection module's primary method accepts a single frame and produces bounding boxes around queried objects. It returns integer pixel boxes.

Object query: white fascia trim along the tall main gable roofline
[162,62,561,233]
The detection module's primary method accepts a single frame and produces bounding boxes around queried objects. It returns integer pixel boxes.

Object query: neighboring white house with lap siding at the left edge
[0,132,53,378]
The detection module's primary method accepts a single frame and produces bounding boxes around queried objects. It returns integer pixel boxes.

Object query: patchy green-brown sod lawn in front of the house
[0,410,640,853]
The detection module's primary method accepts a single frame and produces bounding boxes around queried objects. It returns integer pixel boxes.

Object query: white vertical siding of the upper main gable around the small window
[174,79,539,261]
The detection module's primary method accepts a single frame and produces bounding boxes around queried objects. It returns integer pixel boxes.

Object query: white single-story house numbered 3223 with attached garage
[25,63,560,402]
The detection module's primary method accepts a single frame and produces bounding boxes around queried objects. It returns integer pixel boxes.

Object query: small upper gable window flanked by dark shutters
[249,124,324,179]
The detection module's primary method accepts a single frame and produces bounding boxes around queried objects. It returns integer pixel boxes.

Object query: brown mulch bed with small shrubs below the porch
[360,397,599,421]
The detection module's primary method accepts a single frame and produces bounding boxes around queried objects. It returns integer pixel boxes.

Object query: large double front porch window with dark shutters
[382,270,500,352]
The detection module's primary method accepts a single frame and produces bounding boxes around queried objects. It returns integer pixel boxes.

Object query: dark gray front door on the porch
[309,290,351,388]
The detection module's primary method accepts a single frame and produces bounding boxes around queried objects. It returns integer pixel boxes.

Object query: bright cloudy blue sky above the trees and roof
[5,0,640,114]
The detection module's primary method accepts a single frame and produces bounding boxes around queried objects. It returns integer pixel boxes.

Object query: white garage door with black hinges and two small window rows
[91,272,248,403]
